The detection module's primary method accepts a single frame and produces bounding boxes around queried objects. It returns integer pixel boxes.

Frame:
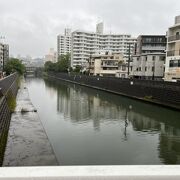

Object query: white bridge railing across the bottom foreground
[0,165,180,180]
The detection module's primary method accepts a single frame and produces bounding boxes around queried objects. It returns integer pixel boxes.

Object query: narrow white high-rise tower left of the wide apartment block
[57,29,71,58]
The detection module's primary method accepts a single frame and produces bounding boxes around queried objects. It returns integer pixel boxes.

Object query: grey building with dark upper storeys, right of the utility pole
[130,35,166,80]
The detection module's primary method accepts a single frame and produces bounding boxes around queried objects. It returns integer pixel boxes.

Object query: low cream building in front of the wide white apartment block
[89,51,127,78]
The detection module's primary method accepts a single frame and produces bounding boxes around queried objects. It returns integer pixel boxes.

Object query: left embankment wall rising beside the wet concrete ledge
[0,73,18,166]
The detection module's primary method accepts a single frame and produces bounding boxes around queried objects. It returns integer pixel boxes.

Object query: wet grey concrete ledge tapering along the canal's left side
[3,79,58,166]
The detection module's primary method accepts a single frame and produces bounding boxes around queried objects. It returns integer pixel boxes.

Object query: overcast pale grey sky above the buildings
[0,0,180,57]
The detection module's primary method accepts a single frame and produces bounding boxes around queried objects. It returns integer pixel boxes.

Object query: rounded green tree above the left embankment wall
[4,58,25,75]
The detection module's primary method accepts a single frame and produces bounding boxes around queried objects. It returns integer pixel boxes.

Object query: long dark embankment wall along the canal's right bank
[48,72,180,110]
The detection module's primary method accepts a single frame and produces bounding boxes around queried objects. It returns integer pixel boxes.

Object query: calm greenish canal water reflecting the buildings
[26,78,180,165]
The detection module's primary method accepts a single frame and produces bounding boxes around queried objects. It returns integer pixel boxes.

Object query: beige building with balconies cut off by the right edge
[164,16,180,81]
